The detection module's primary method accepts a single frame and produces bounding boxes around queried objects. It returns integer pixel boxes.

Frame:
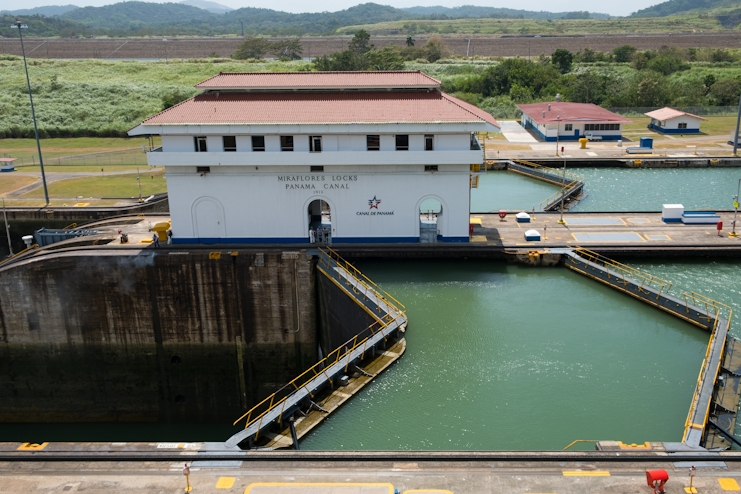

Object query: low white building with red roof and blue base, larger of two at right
[517,101,631,142]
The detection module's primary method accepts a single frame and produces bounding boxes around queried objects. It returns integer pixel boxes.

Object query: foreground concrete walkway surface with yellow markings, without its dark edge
[0,452,741,494]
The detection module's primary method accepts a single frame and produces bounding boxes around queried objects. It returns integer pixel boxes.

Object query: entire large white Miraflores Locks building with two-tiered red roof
[129,72,498,243]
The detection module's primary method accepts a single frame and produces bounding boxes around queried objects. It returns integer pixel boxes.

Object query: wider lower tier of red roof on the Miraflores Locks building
[137,90,499,127]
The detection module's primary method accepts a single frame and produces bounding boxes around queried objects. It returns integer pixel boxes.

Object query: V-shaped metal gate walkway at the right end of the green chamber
[559,248,738,448]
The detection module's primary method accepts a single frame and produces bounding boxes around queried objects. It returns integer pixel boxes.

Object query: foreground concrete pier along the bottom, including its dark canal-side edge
[0,443,741,494]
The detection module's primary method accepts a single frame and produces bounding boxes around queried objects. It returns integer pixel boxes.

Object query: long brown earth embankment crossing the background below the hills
[0,32,741,60]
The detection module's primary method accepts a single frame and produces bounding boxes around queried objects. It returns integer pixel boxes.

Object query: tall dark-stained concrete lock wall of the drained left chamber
[0,250,317,422]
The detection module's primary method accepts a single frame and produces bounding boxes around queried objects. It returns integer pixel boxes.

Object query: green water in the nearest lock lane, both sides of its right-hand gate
[302,261,741,450]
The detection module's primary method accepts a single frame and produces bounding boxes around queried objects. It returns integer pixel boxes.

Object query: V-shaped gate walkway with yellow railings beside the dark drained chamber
[226,249,407,447]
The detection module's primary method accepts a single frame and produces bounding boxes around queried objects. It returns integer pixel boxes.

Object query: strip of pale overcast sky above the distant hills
[0,0,663,15]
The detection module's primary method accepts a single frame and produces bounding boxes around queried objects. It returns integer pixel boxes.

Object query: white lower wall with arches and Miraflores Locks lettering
[166,165,470,239]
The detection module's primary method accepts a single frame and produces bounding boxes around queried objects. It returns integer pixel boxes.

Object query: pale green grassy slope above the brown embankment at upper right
[338,14,725,35]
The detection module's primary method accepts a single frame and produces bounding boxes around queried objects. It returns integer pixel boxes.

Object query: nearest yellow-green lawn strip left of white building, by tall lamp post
[21,172,167,199]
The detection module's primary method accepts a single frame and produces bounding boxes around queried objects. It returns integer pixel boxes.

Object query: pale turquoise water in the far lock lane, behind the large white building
[471,168,741,213]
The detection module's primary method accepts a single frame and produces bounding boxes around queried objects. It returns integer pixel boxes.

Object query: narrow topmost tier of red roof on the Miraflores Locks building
[196,70,440,90]
